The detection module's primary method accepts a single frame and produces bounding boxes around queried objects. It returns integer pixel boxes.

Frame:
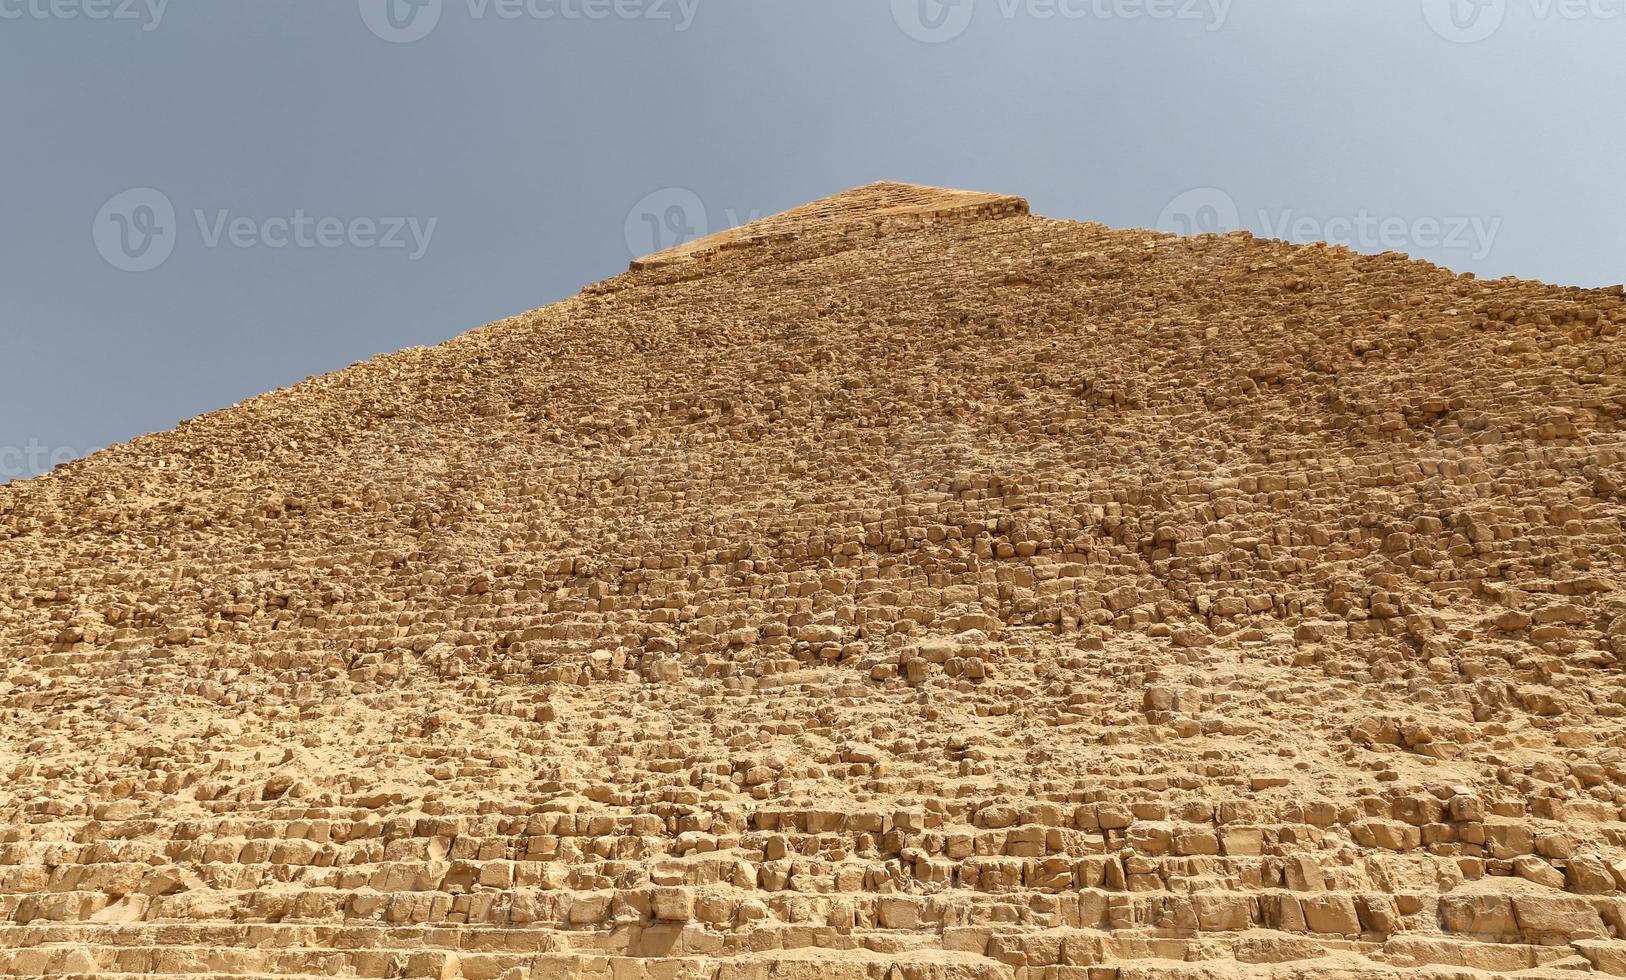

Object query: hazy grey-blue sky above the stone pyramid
[0,0,1626,481]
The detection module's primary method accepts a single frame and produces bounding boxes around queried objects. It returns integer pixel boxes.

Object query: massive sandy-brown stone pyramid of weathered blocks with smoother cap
[0,184,1626,980]
